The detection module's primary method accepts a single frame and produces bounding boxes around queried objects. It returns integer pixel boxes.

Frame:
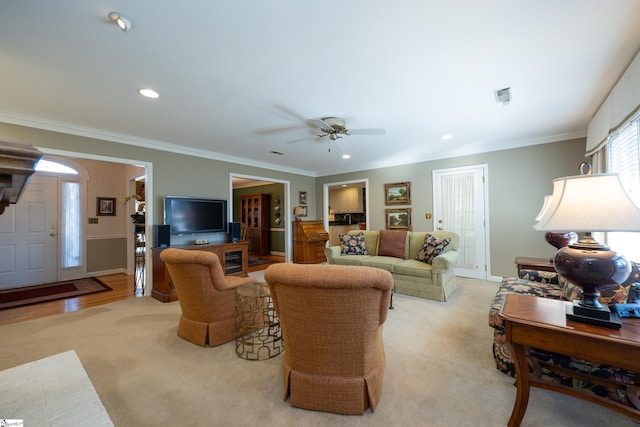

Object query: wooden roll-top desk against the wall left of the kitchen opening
[293,221,329,264]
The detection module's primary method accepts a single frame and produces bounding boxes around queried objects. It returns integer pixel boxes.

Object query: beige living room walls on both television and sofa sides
[0,123,585,276]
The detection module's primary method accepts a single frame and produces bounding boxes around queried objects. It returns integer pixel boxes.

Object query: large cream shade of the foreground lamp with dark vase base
[533,174,640,232]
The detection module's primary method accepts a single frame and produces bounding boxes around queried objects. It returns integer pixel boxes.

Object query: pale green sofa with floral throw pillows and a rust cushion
[325,230,460,301]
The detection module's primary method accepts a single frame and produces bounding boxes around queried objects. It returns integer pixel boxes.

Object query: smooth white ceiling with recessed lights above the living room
[0,0,640,176]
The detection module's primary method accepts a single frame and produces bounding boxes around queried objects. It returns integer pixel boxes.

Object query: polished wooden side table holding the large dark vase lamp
[500,294,640,427]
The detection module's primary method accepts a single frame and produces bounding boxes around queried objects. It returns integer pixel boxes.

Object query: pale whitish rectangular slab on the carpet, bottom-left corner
[0,350,113,426]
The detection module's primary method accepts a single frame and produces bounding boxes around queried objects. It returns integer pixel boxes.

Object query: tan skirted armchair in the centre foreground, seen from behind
[264,264,393,414]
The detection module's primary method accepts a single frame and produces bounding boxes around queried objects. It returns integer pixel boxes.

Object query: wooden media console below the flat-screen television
[151,240,249,302]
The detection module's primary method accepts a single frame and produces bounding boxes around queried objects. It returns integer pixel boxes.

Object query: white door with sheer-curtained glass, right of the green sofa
[433,165,488,279]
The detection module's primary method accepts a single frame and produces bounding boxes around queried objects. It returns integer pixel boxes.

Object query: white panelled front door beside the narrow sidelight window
[0,175,58,289]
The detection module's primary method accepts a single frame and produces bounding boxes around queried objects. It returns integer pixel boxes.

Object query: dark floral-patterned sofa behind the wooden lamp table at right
[489,262,640,409]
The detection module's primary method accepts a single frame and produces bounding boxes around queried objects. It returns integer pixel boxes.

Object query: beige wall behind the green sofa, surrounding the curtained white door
[316,139,585,276]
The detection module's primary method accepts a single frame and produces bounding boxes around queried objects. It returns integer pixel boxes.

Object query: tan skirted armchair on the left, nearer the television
[160,248,256,346]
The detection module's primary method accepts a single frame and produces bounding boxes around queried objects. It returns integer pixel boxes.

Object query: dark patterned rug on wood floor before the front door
[0,277,111,310]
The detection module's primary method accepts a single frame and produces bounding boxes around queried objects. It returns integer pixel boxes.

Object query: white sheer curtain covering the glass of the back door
[441,173,478,269]
